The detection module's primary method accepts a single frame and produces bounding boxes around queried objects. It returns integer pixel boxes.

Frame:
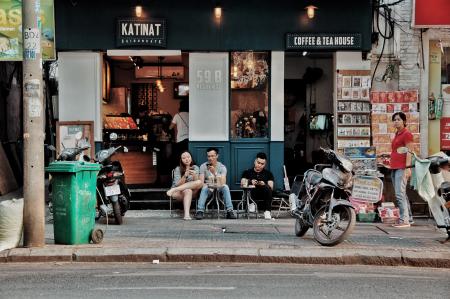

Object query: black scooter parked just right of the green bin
[95,146,131,224]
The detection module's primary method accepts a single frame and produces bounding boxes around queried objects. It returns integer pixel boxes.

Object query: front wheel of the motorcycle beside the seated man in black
[313,206,356,246]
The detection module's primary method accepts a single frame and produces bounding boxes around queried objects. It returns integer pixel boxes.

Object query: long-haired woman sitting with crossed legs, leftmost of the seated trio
[167,151,203,220]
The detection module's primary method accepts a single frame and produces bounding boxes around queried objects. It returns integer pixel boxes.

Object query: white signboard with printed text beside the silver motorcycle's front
[352,176,383,203]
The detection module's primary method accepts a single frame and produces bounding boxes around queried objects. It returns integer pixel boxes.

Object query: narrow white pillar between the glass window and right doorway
[270,52,284,141]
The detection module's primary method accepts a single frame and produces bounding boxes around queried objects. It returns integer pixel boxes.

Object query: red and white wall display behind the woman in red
[370,90,420,159]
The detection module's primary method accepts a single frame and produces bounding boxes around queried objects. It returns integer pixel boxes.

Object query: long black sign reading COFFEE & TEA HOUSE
[286,33,362,50]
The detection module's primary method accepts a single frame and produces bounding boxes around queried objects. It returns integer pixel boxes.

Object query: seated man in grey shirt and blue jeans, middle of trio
[195,147,236,220]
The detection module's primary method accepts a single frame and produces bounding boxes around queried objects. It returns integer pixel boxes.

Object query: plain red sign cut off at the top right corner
[413,0,450,28]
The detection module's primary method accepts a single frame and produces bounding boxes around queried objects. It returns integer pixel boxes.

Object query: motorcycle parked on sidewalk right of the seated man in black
[289,148,356,246]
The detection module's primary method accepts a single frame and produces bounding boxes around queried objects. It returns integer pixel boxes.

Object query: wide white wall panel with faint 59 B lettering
[189,53,230,141]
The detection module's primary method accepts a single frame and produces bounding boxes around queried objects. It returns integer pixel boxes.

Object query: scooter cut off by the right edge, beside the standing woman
[397,147,450,243]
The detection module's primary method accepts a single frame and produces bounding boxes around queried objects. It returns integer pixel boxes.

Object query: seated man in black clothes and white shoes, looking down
[241,153,273,219]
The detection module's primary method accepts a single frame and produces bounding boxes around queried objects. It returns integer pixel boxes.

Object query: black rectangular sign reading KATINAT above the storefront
[116,18,167,48]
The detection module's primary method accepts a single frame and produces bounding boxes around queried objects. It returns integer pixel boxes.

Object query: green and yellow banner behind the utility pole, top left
[0,0,56,61]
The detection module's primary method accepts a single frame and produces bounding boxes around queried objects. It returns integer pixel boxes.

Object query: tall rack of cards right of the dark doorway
[335,70,371,150]
